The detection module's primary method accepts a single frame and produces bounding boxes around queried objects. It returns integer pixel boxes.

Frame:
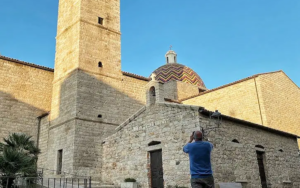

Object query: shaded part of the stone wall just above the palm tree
[0,91,46,142]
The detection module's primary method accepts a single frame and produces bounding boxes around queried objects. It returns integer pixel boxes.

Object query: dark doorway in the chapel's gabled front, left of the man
[150,150,164,188]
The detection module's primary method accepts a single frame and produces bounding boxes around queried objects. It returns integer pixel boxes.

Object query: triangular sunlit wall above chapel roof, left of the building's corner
[182,79,262,124]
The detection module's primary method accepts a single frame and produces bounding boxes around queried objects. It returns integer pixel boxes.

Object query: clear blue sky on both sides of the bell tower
[0,0,300,89]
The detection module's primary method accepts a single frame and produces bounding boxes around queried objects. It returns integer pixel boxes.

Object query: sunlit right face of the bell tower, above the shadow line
[79,0,121,77]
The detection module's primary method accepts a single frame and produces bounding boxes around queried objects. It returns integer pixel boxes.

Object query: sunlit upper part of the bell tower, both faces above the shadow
[55,0,121,80]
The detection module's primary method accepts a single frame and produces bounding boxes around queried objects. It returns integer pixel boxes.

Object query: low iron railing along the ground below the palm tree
[0,176,92,188]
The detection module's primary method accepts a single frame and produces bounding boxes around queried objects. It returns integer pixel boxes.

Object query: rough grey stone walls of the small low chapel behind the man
[102,104,300,188]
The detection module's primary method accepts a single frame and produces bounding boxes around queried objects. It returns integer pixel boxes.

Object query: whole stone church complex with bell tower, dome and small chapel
[0,0,300,188]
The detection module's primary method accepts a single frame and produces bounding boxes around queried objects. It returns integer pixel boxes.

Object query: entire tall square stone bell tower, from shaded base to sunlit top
[46,0,122,177]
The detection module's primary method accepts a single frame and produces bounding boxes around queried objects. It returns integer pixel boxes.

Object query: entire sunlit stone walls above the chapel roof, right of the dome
[182,71,300,147]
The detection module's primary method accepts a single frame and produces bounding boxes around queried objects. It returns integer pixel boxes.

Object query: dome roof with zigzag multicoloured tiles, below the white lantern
[153,63,206,89]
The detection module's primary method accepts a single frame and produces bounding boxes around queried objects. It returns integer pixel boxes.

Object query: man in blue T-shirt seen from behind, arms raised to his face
[183,131,215,188]
